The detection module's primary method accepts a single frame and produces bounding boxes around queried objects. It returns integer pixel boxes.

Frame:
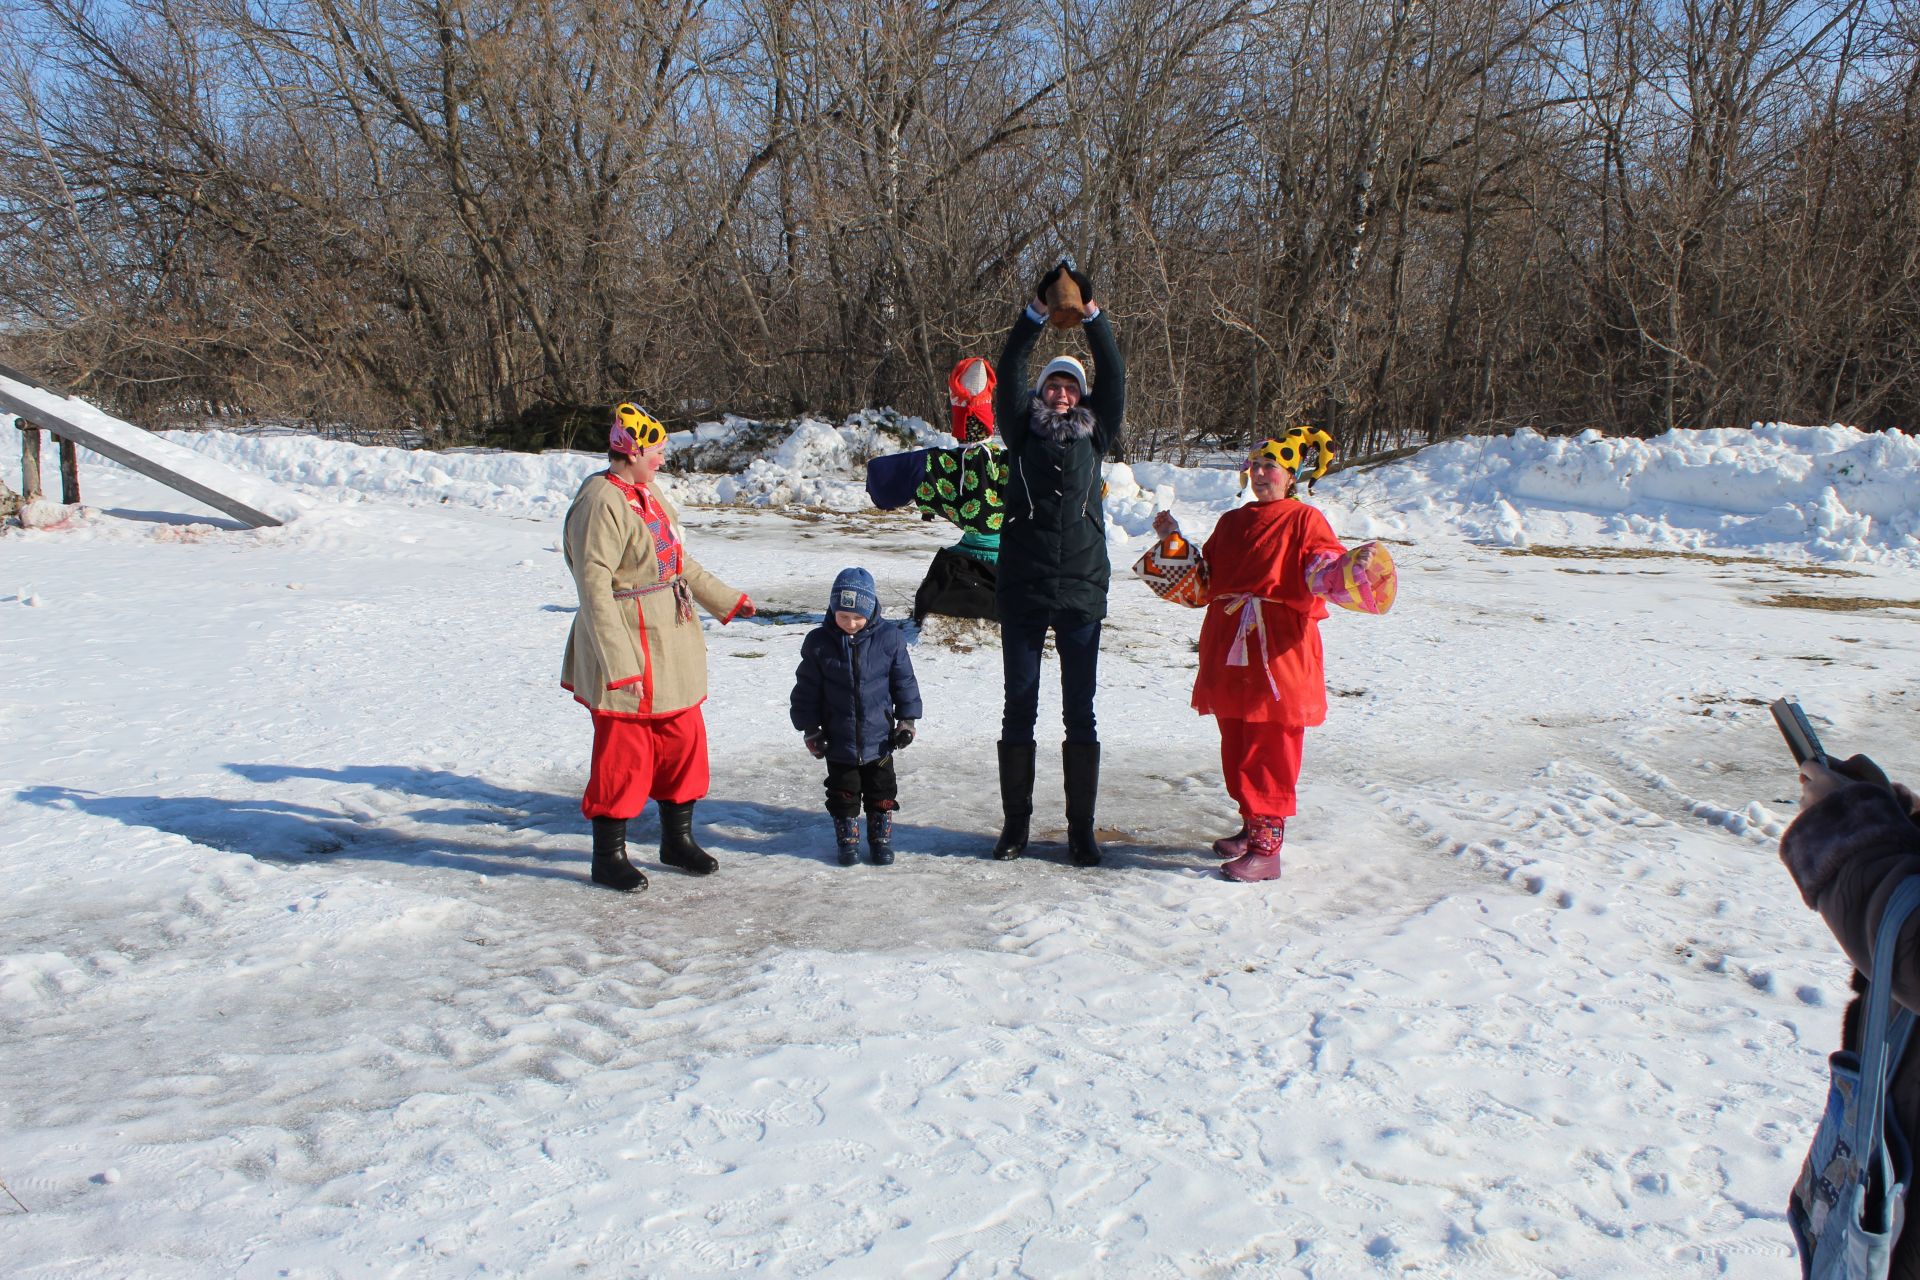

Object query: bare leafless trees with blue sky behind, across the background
[0,0,1920,457]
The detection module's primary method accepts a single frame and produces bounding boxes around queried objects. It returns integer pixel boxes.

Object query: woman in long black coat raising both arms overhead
[993,263,1127,867]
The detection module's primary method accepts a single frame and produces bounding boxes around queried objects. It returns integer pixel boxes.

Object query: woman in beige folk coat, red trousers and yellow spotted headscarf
[561,405,753,890]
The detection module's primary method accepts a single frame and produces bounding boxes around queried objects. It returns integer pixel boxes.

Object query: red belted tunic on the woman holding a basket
[1194,499,1346,727]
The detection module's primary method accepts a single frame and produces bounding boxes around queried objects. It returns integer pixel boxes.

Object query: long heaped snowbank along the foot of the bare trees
[101,411,1920,564]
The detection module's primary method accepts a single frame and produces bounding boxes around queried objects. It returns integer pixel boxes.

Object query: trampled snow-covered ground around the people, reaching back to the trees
[0,426,1920,1280]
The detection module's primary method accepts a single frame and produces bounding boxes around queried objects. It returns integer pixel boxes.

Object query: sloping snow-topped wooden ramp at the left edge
[0,365,300,528]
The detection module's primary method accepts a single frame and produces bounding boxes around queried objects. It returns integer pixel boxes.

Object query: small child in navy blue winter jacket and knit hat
[793,568,920,867]
